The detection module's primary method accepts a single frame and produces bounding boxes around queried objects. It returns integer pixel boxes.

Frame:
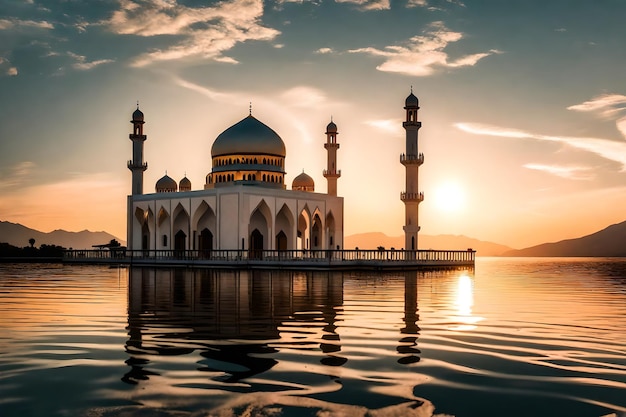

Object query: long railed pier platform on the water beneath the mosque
[63,249,476,270]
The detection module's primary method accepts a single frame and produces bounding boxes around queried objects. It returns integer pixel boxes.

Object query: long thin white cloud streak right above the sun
[455,123,626,172]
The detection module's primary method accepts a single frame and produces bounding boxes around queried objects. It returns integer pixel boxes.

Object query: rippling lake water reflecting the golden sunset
[0,258,626,417]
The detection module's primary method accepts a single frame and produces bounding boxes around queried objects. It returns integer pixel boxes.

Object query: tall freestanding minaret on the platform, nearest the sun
[400,88,424,250]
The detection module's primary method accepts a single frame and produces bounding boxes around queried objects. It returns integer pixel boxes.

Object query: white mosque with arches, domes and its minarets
[127,91,424,256]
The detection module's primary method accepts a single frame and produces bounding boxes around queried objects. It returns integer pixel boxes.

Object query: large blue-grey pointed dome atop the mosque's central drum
[211,115,287,158]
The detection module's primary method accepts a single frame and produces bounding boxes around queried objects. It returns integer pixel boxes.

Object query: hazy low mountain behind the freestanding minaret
[343,232,512,256]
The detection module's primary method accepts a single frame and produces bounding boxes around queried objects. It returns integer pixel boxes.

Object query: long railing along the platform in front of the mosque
[63,249,476,265]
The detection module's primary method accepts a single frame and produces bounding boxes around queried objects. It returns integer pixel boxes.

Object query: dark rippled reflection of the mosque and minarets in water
[122,268,419,384]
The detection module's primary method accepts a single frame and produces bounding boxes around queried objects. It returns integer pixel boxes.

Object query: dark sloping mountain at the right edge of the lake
[502,221,626,257]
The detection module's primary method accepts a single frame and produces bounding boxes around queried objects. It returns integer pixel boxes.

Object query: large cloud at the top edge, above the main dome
[104,0,280,67]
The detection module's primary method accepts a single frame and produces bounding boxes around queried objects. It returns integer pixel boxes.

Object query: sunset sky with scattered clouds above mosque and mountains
[0,0,626,248]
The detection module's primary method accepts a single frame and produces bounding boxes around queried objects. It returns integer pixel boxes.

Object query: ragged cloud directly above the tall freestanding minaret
[348,22,500,77]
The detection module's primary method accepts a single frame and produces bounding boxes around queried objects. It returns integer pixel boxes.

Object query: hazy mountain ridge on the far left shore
[0,221,125,249]
